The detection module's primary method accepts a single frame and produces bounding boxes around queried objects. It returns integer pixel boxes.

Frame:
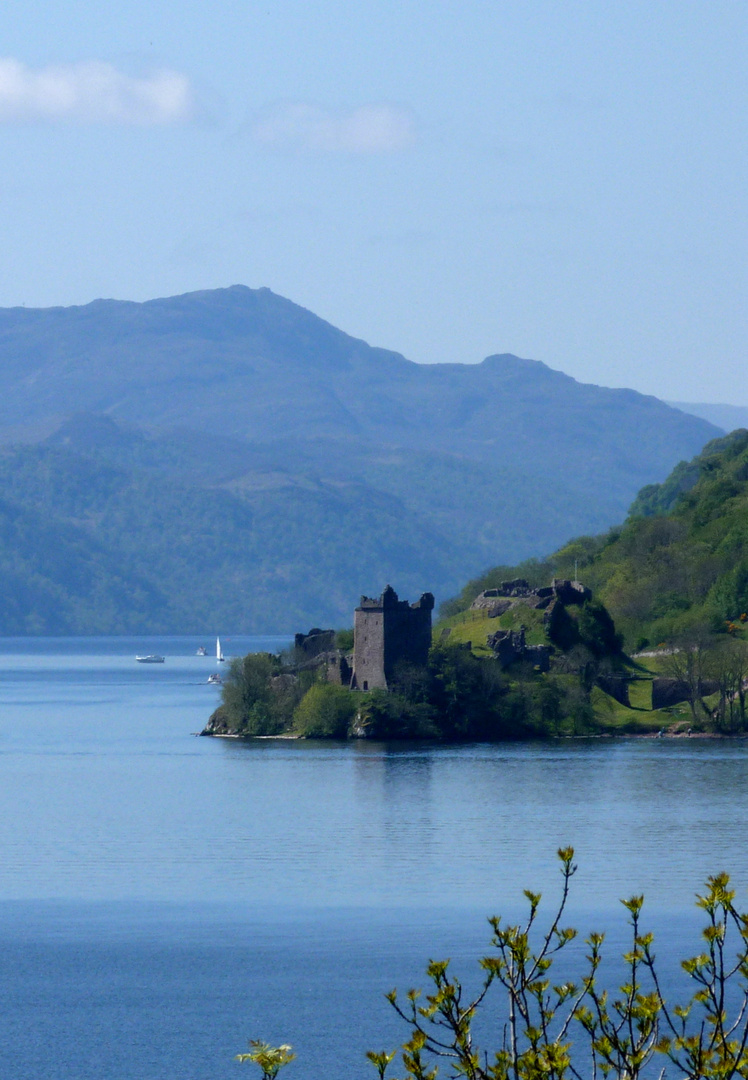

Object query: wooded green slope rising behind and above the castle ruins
[445,429,748,650]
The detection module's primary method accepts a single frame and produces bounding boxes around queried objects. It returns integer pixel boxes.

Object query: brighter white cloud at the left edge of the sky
[0,57,194,124]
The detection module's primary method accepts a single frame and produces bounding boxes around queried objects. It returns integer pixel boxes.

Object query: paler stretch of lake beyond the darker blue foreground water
[0,638,748,909]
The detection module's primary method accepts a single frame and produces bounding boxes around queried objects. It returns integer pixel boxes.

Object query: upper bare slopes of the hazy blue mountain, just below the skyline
[0,286,715,460]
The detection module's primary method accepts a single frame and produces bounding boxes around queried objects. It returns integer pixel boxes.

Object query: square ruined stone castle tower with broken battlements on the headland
[351,585,434,690]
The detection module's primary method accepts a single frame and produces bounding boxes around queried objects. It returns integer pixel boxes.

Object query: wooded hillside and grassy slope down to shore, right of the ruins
[443,430,748,733]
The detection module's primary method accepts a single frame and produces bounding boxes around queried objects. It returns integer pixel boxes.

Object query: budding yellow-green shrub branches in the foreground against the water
[243,848,748,1080]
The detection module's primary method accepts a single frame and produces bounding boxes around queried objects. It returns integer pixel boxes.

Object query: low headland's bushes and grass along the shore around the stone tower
[201,598,748,742]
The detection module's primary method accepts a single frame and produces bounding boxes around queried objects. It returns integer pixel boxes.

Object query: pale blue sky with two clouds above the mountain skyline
[0,0,748,404]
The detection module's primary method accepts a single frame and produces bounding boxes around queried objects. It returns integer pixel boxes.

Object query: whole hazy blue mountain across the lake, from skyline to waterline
[0,286,718,633]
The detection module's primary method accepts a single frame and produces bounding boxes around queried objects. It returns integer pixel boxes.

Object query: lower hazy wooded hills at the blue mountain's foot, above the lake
[0,446,454,634]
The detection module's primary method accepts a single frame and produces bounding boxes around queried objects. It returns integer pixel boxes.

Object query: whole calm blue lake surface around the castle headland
[0,638,748,1080]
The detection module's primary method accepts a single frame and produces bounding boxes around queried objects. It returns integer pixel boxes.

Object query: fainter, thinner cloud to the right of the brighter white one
[253,103,416,153]
